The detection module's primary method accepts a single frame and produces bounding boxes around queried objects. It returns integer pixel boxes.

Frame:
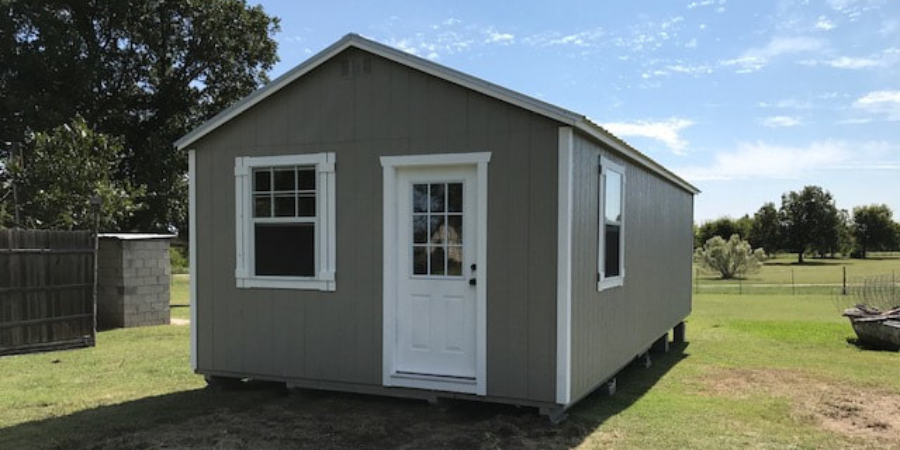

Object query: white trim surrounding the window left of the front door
[234,152,337,291]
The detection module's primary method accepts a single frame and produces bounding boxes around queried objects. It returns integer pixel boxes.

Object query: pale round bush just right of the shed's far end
[694,234,766,280]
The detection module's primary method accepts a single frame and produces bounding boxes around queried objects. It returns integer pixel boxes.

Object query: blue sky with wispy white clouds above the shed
[255,0,900,222]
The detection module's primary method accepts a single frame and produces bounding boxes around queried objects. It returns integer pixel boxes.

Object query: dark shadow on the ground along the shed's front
[0,344,687,449]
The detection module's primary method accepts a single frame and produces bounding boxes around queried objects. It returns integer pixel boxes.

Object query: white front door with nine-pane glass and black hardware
[393,166,478,383]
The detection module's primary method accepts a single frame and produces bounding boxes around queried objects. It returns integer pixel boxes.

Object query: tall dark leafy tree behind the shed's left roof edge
[0,0,278,230]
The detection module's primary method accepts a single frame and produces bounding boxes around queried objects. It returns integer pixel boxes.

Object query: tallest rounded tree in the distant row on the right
[779,186,840,264]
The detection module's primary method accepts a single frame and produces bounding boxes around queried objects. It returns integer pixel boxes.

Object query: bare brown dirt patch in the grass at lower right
[701,369,900,447]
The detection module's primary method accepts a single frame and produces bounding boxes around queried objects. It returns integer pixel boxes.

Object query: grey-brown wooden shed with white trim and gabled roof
[176,34,698,415]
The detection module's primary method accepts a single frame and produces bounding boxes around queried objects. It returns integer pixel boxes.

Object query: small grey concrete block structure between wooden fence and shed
[97,233,175,329]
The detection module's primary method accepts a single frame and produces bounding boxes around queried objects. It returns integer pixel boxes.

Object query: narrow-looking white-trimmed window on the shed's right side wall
[597,156,625,290]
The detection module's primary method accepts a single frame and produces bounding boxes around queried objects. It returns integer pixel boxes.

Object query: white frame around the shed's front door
[381,152,491,396]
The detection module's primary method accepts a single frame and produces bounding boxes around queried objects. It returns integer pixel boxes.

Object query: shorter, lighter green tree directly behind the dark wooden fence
[2,117,143,230]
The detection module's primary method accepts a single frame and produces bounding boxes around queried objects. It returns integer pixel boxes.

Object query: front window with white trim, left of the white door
[234,153,335,291]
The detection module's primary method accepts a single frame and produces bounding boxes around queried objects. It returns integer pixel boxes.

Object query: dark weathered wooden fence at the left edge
[0,230,95,355]
